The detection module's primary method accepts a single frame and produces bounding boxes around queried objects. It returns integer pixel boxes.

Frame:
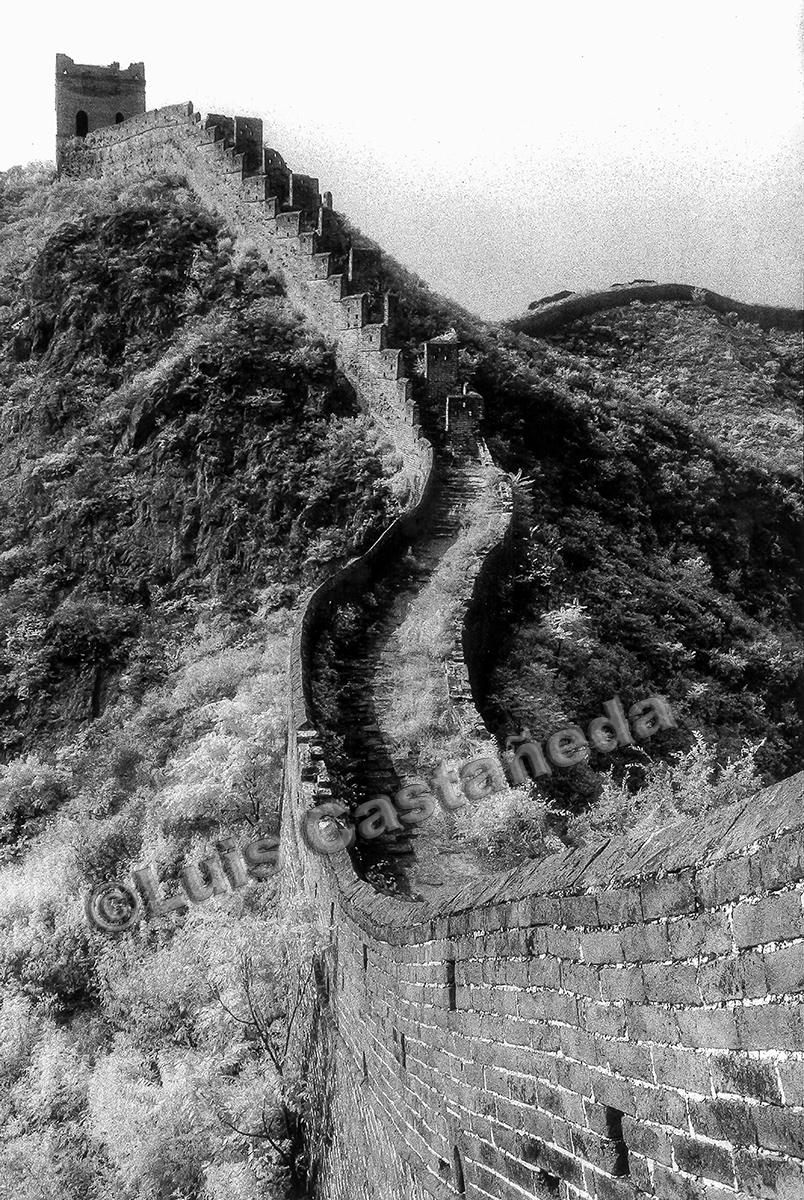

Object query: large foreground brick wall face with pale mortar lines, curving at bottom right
[286,740,804,1200]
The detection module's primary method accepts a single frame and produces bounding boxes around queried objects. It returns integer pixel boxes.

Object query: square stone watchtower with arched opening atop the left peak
[56,54,145,161]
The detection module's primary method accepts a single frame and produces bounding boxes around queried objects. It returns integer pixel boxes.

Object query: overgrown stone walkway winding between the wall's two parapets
[313,451,509,899]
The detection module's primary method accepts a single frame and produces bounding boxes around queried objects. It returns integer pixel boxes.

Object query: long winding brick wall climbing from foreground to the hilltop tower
[60,70,804,1200]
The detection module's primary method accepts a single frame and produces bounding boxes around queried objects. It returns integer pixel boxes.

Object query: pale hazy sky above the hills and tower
[0,0,804,317]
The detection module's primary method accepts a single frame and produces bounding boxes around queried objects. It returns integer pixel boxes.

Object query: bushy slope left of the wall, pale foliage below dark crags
[0,169,403,1200]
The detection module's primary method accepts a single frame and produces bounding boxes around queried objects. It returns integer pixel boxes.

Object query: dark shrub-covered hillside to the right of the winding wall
[474,306,802,803]
